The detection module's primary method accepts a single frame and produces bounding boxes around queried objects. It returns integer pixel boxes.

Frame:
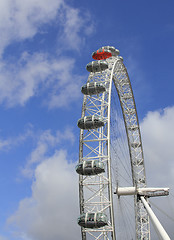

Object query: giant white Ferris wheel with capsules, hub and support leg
[76,46,170,240]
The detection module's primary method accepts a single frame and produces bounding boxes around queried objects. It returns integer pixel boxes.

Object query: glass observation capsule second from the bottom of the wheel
[76,160,105,175]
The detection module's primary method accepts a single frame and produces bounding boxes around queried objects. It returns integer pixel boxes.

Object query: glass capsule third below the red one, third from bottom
[77,115,104,129]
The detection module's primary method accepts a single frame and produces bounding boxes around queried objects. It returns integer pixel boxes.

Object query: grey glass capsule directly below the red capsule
[86,60,108,72]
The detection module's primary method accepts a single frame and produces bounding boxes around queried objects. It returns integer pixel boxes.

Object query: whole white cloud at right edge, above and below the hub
[141,107,174,239]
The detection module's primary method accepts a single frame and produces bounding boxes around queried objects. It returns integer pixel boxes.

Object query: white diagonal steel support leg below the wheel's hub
[141,197,171,240]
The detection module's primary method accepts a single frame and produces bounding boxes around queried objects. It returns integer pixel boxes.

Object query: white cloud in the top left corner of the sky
[0,0,93,55]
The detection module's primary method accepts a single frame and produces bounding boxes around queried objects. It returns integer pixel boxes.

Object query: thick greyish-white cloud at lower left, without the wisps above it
[8,150,80,240]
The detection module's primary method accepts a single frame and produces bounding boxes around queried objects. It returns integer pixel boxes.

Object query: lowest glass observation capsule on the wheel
[77,212,108,228]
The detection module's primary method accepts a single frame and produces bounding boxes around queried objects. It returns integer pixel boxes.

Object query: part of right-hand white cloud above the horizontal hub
[141,107,174,187]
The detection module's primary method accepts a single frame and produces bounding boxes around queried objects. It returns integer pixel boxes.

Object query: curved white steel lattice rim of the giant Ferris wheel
[79,46,150,240]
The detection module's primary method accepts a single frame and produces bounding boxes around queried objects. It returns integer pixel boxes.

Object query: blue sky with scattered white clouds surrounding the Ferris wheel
[0,0,174,240]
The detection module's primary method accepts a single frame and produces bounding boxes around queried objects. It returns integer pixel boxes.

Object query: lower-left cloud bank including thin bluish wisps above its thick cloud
[8,128,80,240]
